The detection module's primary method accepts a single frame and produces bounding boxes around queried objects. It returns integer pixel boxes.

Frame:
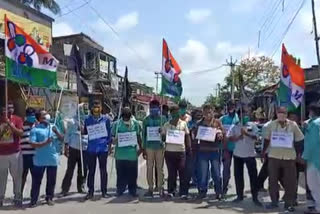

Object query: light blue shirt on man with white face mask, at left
[30,124,60,166]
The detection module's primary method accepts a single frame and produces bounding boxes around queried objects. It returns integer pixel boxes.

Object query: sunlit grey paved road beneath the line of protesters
[0,157,305,214]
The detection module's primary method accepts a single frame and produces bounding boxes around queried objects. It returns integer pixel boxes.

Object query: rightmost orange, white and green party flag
[278,44,305,110]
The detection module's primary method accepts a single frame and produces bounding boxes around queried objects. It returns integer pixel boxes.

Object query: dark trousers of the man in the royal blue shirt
[86,152,108,195]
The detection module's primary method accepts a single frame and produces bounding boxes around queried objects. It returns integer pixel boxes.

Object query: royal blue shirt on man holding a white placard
[84,115,111,153]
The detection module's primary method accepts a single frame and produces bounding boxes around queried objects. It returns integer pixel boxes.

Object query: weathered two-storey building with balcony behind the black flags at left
[51,33,121,112]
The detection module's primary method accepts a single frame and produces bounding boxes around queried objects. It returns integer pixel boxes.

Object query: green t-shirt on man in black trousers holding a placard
[111,119,141,160]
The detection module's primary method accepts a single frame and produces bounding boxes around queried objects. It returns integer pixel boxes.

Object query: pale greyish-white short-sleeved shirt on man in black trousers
[227,122,259,158]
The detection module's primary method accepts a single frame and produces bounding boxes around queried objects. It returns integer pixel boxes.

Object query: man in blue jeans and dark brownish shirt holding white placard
[194,105,223,199]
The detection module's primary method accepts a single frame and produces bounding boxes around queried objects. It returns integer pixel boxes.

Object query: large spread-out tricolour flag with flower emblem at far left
[5,17,58,88]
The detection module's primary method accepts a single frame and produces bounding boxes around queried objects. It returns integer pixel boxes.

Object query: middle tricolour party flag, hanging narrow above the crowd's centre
[161,39,182,98]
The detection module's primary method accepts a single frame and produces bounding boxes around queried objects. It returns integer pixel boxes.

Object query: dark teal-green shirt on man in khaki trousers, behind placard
[142,116,167,150]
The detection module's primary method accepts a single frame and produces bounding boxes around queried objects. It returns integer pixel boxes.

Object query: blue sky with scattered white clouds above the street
[48,0,320,105]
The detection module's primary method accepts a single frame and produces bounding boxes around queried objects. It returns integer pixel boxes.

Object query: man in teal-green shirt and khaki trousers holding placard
[142,100,166,197]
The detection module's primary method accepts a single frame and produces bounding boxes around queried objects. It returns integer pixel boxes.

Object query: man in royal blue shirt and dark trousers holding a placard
[83,100,111,200]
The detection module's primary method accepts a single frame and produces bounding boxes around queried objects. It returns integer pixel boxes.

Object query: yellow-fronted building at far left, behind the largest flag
[0,0,55,115]
